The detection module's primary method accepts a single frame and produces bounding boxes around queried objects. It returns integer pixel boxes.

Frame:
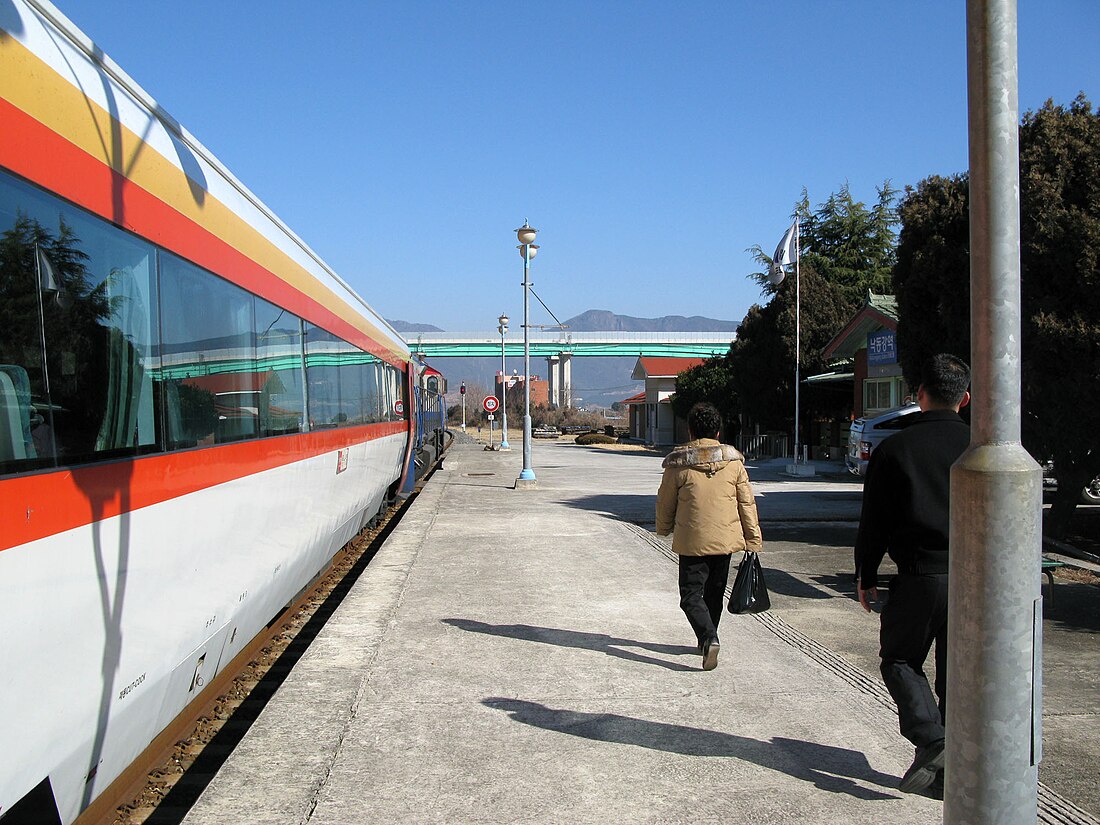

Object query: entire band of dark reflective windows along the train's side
[0,166,404,474]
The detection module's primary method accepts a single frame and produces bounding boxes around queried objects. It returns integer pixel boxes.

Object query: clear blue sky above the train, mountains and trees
[57,0,1100,331]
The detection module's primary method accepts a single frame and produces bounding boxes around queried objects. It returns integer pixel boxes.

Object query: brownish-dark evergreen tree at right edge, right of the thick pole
[1020,95,1100,535]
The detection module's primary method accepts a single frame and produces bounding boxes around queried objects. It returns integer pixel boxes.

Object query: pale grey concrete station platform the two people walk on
[185,442,1100,825]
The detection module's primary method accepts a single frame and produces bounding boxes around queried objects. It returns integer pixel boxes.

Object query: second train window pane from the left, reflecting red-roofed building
[161,253,256,449]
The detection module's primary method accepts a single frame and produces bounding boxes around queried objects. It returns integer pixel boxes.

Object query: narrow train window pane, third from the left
[255,298,306,436]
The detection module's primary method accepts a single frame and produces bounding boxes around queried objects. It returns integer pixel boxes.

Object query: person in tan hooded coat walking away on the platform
[657,402,763,670]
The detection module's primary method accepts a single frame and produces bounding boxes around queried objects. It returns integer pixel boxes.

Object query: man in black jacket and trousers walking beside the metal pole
[856,354,970,799]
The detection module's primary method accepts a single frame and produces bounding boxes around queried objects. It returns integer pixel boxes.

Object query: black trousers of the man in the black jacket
[879,573,947,748]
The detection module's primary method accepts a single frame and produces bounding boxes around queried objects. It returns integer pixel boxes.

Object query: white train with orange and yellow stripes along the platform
[0,0,448,825]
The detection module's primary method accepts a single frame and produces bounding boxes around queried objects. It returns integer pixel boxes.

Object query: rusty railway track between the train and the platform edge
[75,442,453,825]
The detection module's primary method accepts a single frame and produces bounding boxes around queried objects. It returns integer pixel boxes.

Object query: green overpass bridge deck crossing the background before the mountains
[404,330,734,361]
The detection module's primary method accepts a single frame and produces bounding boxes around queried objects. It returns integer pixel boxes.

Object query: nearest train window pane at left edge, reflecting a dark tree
[0,174,157,472]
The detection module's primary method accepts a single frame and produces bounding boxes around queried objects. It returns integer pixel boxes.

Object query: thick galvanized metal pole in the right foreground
[944,0,1043,825]
